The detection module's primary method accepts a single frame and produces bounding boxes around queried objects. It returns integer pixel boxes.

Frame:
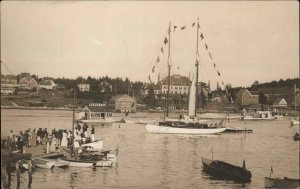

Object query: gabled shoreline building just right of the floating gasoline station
[109,94,136,112]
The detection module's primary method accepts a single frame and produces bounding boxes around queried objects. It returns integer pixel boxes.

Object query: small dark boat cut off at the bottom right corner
[265,177,300,189]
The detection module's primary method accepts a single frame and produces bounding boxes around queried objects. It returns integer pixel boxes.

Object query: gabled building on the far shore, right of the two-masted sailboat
[236,89,259,106]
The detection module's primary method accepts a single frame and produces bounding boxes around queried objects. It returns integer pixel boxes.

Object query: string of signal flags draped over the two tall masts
[148,18,225,87]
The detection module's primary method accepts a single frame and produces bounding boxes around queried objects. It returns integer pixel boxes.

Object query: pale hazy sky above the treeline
[1,1,299,87]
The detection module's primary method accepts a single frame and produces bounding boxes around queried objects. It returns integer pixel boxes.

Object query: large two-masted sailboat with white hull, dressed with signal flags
[145,20,226,135]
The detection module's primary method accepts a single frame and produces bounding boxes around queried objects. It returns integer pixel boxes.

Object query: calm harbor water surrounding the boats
[1,109,299,189]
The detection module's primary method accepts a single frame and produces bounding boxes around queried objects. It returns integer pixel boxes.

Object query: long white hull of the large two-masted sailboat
[146,124,226,135]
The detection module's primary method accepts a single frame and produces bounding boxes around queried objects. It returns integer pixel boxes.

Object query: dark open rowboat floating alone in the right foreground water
[201,157,252,183]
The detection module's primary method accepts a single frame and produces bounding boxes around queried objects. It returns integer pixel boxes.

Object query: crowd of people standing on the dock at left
[2,123,95,153]
